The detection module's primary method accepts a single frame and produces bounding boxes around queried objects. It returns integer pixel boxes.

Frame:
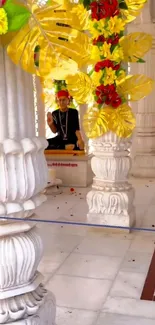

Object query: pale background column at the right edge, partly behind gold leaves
[128,2,155,178]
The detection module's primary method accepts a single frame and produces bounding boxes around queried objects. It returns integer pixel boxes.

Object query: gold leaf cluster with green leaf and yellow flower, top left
[0,0,90,80]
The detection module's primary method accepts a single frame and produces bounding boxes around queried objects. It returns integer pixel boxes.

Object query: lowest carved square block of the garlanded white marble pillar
[87,189,135,228]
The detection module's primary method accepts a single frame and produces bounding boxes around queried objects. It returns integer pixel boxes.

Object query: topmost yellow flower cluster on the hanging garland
[89,16,125,38]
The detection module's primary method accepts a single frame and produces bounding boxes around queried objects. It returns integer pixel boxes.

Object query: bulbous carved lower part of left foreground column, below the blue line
[0,222,56,325]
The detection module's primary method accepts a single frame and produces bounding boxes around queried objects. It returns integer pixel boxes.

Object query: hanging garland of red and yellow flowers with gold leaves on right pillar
[66,0,154,138]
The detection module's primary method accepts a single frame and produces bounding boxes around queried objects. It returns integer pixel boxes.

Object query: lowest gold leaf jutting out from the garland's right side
[117,74,154,101]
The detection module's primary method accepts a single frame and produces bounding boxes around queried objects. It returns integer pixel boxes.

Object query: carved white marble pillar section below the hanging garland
[87,132,135,227]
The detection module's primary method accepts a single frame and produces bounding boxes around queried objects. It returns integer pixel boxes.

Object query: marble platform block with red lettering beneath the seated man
[46,154,93,187]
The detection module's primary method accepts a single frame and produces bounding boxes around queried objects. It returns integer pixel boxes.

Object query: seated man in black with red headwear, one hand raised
[46,90,84,150]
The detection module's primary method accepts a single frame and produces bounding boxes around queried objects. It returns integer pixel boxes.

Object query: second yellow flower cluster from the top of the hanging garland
[91,42,124,63]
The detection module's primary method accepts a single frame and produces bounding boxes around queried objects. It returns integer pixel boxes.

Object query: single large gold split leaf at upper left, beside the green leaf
[8,1,90,78]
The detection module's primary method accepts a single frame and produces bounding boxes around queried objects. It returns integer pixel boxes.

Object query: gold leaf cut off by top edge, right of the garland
[121,0,147,23]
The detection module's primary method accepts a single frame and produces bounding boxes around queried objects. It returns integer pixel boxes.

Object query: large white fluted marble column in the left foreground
[0,48,55,325]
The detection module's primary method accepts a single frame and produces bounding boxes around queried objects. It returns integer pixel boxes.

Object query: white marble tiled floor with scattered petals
[37,179,155,325]
